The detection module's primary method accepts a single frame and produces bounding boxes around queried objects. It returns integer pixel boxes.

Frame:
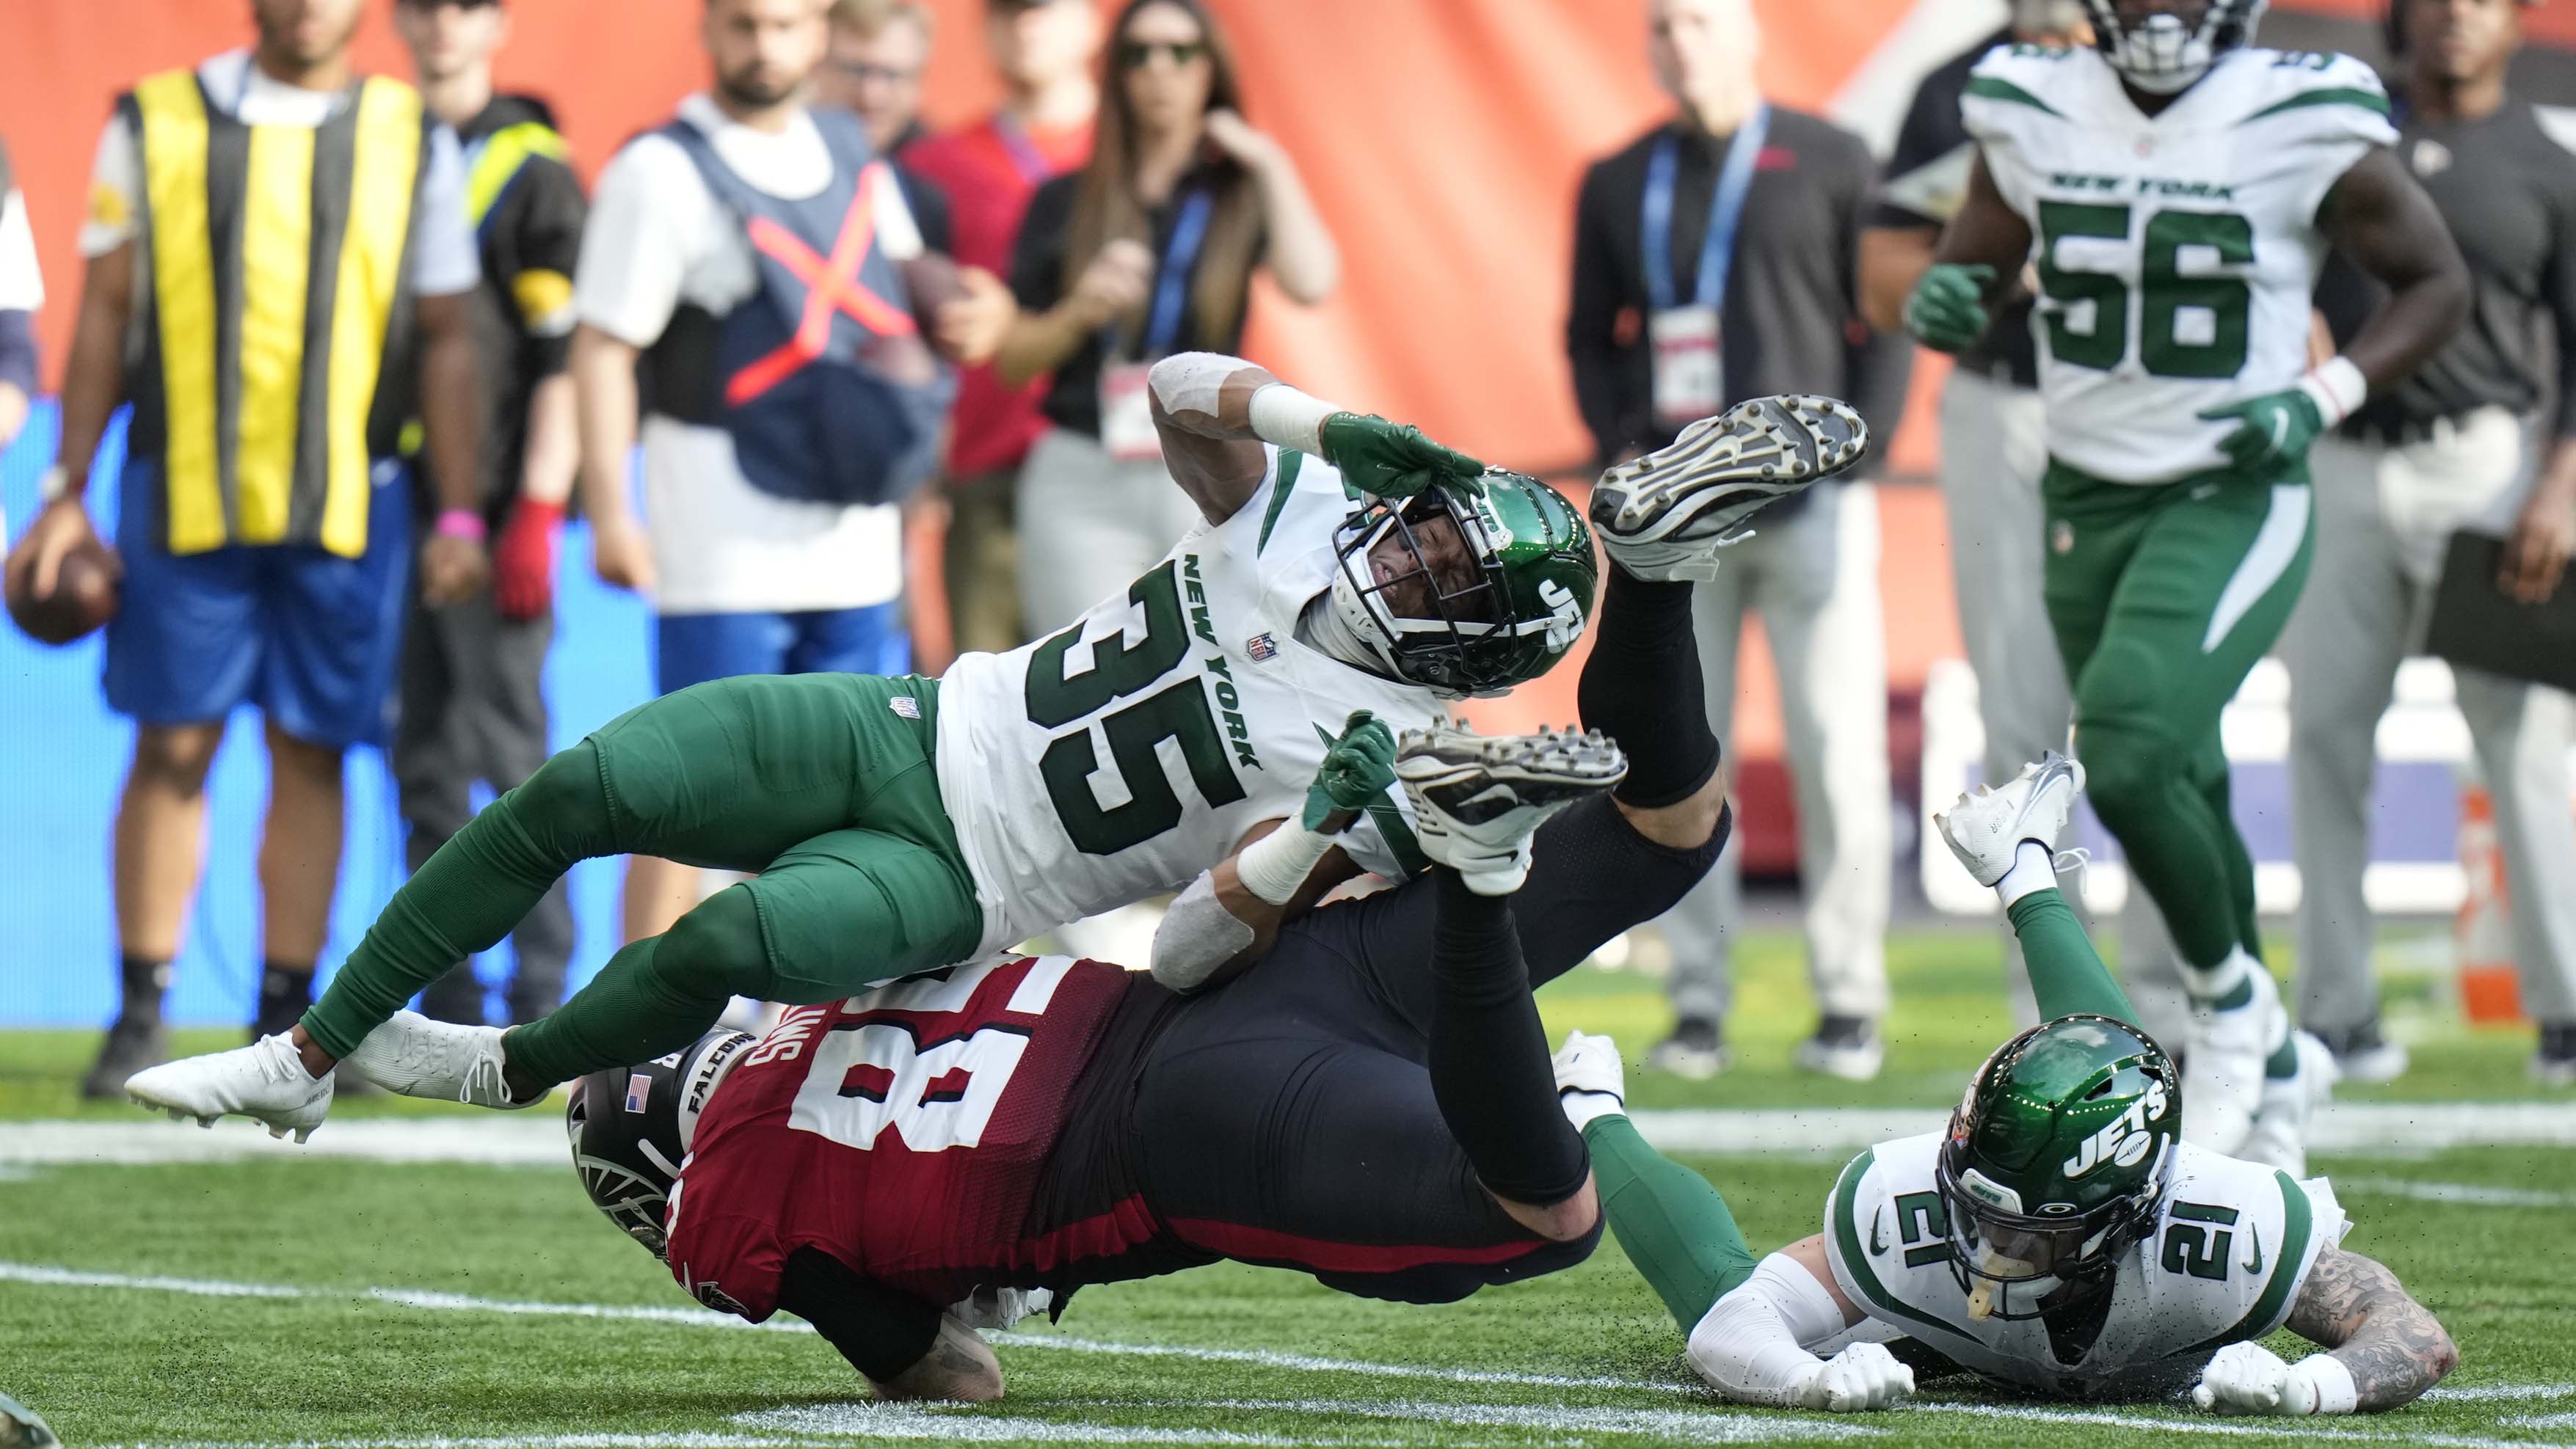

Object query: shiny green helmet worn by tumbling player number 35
[1332,468,1600,700]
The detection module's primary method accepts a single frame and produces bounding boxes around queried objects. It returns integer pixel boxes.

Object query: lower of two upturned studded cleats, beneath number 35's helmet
[1396,723,1628,896]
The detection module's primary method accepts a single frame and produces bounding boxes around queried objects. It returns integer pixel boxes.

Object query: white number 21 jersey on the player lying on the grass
[1824,1133,2349,1398]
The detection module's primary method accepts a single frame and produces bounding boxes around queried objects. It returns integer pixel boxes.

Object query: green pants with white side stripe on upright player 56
[2040,461,2315,983]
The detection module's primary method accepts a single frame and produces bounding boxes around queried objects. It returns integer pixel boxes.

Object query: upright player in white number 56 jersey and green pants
[1906,0,2468,1153]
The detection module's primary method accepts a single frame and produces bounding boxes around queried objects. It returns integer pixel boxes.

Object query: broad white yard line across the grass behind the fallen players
[15,1099,2576,1173]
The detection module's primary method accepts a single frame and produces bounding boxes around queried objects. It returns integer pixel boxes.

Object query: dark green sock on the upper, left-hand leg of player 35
[304,741,615,1060]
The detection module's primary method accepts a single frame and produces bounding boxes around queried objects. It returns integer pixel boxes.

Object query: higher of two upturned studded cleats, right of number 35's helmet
[1590,396,1870,584]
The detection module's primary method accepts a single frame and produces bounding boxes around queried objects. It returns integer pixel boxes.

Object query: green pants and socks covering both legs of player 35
[304,674,984,1084]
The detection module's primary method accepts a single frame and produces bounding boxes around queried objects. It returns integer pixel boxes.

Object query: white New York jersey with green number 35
[938,448,1445,965]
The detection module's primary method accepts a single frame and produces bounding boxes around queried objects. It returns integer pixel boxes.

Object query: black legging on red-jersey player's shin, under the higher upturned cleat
[1574,563,1718,811]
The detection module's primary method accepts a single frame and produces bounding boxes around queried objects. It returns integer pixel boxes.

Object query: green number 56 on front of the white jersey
[2040,201,2254,379]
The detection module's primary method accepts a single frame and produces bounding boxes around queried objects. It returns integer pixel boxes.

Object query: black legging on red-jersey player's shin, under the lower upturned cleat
[1430,867,1592,1207]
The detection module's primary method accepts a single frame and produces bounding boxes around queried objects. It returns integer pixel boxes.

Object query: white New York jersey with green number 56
[1960,46,2395,484]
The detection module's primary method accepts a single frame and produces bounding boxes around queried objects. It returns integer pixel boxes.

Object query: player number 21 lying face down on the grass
[1559,754,2458,1415]
